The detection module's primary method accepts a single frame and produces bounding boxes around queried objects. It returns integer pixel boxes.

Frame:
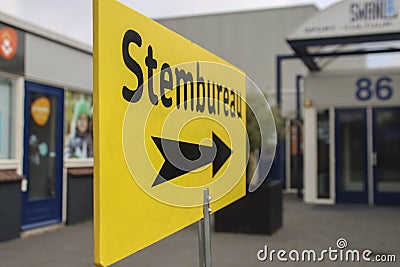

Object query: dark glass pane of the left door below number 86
[336,110,367,191]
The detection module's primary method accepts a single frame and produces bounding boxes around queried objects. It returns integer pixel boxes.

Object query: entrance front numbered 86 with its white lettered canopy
[288,0,400,205]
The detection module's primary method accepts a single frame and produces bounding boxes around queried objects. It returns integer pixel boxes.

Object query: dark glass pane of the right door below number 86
[375,109,400,192]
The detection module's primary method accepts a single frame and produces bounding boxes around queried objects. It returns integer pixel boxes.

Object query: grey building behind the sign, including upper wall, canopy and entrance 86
[159,0,400,205]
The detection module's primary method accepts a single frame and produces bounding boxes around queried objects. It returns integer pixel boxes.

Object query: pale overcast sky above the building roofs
[0,0,338,45]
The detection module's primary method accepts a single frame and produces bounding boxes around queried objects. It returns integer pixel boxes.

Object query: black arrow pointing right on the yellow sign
[151,133,232,187]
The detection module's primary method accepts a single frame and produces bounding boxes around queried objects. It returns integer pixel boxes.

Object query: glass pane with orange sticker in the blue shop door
[28,92,57,198]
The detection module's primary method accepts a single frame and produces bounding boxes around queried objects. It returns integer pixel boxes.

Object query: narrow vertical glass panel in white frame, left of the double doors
[317,110,330,198]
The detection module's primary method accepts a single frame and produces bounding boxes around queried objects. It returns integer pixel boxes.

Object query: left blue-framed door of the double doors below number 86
[335,109,368,203]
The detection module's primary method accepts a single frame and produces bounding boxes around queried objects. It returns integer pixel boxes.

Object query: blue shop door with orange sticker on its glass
[22,82,64,229]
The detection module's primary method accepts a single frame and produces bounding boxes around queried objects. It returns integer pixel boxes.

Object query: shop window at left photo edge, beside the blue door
[0,77,15,160]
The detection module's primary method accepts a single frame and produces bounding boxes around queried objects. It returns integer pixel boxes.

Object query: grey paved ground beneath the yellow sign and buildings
[0,195,400,267]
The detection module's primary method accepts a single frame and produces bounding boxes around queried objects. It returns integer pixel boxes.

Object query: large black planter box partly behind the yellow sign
[214,180,282,235]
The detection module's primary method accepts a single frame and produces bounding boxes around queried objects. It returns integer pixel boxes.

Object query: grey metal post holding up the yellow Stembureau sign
[198,188,211,267]
